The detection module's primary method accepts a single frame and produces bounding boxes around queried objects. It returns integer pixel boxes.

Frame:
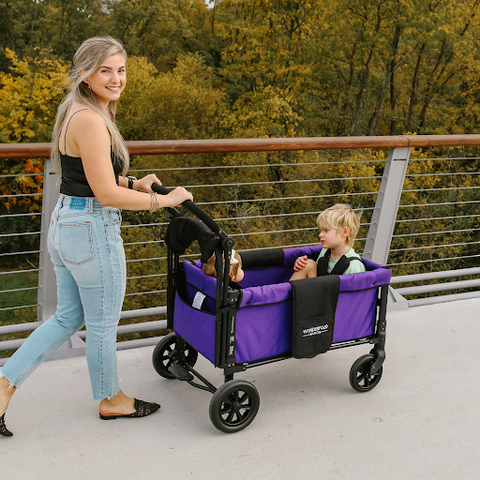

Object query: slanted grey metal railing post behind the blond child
[363,147,410,265]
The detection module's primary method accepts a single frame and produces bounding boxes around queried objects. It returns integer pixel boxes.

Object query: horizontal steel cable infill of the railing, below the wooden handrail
[0,139,480,360]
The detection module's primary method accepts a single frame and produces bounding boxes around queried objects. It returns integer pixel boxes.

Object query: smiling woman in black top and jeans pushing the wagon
[0,37,192,436]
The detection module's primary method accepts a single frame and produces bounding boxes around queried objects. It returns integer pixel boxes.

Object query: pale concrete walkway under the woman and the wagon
[0,299,480,480]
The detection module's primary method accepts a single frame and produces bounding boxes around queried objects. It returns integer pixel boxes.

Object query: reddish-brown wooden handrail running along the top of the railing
[0,135,480,158]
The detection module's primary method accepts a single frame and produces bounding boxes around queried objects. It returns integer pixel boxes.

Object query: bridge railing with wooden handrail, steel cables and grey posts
[0,135,480,362]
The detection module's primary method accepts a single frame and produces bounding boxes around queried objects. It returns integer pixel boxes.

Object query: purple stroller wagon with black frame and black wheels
[153,188,391,433]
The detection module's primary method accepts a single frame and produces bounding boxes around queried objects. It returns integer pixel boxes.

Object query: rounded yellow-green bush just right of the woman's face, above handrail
[118,54,223,140]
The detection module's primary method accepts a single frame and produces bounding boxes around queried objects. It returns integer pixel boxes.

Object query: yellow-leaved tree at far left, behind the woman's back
[0,49,68,270]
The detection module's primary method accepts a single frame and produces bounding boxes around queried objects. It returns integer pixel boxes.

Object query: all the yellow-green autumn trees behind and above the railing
[0,0,480,322]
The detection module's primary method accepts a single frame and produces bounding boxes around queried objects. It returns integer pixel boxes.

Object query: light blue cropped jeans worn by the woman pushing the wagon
[0,195,126,400]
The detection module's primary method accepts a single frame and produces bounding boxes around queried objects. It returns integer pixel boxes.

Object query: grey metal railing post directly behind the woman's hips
[37,158,60,322]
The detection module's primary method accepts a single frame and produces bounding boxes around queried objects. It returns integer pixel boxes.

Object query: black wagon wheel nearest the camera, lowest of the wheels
[209,380,260,433]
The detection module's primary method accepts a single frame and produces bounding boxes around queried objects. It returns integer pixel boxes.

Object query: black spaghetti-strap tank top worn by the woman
[59,108,123,197]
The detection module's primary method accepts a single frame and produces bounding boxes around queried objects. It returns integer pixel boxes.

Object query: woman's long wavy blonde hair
[51,36,129,175]
